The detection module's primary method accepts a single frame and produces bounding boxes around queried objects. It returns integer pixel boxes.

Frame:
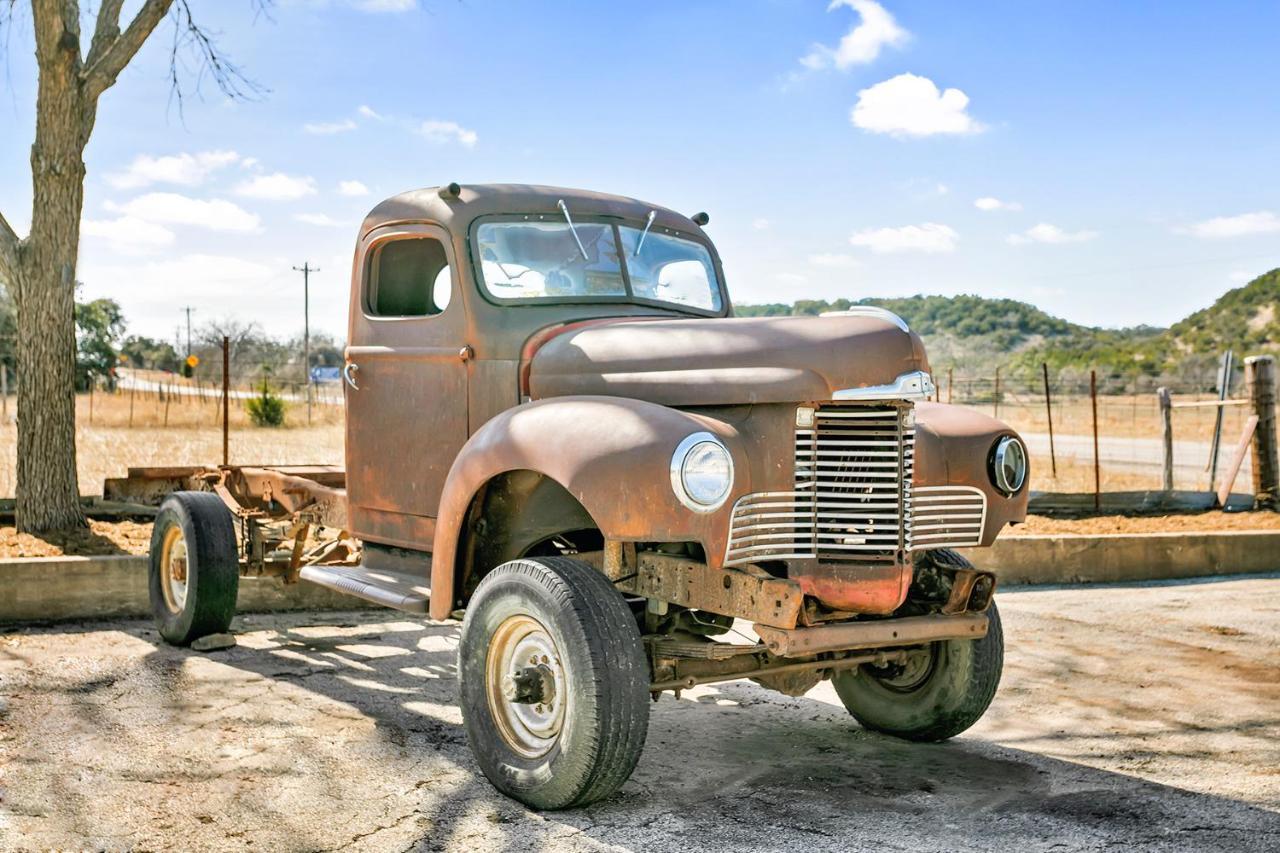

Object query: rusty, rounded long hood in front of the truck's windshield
[529,315,928,406]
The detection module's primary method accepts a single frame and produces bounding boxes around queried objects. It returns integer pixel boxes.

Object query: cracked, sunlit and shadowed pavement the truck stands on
[0,578,1280,853]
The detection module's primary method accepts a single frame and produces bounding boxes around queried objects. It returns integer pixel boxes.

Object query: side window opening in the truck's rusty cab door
[366,237,453,316]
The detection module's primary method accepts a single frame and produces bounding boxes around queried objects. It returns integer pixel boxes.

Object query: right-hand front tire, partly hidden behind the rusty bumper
[832,603,1005,742]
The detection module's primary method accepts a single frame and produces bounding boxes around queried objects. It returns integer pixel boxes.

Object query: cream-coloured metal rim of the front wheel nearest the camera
[485,615,568,758]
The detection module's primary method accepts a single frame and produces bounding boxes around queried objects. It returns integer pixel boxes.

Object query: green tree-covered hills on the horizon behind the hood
[736,269,1280,386]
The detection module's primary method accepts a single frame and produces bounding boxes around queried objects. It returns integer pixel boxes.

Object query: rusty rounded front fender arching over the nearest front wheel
[430,396,751,619]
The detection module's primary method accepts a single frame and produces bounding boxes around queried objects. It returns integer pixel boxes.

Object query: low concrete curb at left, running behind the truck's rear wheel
[0,555,370,625]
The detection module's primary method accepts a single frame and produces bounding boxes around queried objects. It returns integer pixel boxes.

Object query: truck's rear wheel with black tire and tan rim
[150,492,239,646]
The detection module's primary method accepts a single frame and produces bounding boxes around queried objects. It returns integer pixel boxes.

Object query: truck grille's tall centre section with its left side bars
[724,406,915,565]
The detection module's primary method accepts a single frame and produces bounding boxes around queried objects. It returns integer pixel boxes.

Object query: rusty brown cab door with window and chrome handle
[343,225,471,551]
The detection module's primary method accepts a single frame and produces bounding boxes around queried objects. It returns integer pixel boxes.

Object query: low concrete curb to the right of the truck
[961,530,1280,585]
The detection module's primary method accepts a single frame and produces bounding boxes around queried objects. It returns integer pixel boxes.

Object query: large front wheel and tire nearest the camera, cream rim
[458,557,649,809]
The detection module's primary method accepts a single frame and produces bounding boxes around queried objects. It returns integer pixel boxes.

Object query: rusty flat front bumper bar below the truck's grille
[755,613,987,657]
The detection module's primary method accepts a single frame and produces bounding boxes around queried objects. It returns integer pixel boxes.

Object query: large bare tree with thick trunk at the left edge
[0,0,261,532]
